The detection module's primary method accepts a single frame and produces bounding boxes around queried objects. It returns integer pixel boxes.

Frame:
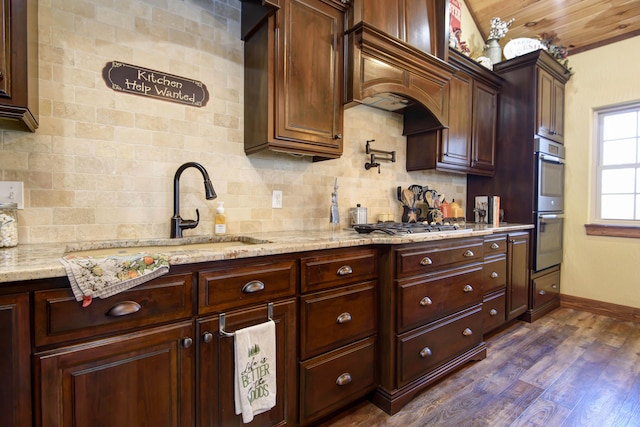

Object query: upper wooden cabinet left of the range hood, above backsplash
[242,0,346,160]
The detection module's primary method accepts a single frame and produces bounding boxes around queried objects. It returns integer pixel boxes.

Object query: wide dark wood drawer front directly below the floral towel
[34,274,193,346]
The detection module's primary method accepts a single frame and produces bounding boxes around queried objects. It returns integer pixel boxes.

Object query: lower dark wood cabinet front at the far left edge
[0,293,32,427]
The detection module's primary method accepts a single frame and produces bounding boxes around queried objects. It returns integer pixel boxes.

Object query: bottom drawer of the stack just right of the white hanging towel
[300,337,376,425]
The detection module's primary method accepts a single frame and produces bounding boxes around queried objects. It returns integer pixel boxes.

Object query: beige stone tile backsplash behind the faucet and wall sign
[0,0,466,244]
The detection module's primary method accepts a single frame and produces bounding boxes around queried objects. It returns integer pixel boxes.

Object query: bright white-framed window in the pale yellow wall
[594,103,640,226]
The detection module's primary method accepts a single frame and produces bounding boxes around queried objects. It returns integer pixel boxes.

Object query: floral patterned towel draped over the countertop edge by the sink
[60,253,169,307]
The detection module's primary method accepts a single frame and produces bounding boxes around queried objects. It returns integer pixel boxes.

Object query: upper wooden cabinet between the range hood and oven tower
[404,49,501,176]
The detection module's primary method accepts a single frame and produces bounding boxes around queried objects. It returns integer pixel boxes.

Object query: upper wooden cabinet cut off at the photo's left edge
[0,0,38,132]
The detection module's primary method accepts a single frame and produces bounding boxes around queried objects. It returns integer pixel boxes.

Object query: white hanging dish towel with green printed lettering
[234,320,276,424]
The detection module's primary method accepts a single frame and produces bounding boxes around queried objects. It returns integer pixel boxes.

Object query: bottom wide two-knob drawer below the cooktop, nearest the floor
[397,304,482,386]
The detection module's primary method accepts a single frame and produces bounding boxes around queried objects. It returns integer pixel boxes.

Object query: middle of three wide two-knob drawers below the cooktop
[398,263,483,332]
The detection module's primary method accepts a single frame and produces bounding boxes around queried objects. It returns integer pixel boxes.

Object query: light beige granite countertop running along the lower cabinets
[0,224,533,286]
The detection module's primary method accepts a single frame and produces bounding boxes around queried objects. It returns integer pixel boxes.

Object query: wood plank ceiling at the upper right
[465,0,640,55]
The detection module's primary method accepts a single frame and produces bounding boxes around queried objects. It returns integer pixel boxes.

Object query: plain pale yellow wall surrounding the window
[561,37,640,308]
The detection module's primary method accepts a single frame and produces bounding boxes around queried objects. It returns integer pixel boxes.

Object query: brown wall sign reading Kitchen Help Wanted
[102,61,209,107]
